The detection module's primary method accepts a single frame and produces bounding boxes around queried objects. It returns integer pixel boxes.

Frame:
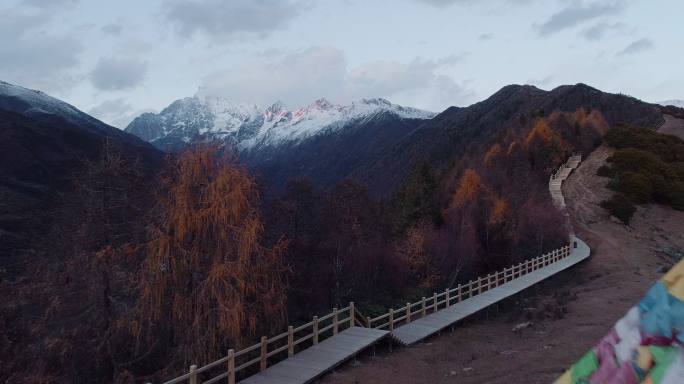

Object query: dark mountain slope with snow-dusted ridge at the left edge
[0,83,163,256]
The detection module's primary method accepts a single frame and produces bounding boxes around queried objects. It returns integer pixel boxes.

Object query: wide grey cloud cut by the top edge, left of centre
[162,0,305,38]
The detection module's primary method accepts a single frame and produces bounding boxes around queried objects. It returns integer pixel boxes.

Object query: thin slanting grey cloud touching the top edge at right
[537,0,625,36]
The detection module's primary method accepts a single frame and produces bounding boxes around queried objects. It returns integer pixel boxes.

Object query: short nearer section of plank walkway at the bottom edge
[240,327,389,384]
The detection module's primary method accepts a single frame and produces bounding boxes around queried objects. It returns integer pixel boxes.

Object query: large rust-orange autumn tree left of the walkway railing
[132,146,286,368]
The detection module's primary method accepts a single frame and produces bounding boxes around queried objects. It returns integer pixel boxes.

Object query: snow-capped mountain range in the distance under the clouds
[126,96,435,151]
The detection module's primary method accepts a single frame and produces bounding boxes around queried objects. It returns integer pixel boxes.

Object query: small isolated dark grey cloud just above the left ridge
[90,57,147,91]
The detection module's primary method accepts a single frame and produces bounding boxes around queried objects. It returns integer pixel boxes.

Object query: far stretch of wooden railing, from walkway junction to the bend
[366,245,570,331]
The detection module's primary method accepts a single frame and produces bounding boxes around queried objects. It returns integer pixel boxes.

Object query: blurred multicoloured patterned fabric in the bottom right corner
[555,260,684,384]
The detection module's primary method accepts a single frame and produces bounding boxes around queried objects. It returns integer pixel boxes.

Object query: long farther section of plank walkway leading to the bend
[391,237,591,345]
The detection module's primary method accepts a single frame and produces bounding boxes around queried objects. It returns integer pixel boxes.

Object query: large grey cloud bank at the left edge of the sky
[0,3,83,91]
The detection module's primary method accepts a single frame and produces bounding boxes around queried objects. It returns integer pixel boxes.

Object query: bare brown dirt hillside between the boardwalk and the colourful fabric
[320,147,684,384]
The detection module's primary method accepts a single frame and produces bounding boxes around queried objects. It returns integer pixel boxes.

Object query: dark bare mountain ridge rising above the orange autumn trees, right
[353,84,662,195]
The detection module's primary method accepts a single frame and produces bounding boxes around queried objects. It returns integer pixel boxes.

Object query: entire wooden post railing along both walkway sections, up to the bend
[156,246,570,384]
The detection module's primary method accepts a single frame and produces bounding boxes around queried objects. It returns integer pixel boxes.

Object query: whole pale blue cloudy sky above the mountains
[0,0,684,128]
